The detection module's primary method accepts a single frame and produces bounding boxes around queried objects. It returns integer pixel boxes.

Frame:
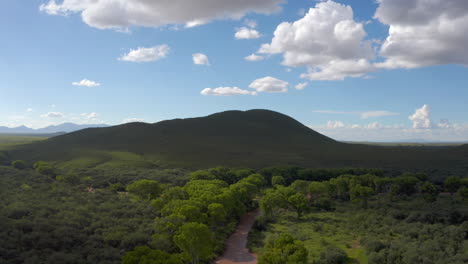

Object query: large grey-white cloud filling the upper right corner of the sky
[375,0,468,69]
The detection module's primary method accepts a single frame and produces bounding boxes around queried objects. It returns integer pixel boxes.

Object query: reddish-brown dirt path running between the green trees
[214,209,260,264]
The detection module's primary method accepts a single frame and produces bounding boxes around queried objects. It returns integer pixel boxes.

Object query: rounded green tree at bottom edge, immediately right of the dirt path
[258,234,308,264]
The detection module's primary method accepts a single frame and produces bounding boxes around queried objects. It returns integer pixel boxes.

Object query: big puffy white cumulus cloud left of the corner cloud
[259,1,375,80]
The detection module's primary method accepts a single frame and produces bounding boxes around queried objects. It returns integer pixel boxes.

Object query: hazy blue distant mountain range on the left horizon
[0,123,108,134]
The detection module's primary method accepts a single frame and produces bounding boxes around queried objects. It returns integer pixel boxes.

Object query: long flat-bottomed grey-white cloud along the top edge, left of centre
[40,0,286,29]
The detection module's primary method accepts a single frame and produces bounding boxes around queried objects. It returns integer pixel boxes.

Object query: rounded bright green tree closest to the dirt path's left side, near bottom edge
[174,223,213,264]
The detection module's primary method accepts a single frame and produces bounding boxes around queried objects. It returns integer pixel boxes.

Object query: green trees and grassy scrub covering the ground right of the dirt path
[250,169,468,264]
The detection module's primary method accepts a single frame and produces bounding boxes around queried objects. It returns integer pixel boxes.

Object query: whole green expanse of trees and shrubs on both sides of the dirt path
[0,160,468,264]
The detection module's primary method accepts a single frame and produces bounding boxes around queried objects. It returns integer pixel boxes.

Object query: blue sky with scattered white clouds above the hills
[0,0,468,141]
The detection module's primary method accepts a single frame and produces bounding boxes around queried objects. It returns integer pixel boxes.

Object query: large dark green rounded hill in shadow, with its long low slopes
[6,110,468,169]
